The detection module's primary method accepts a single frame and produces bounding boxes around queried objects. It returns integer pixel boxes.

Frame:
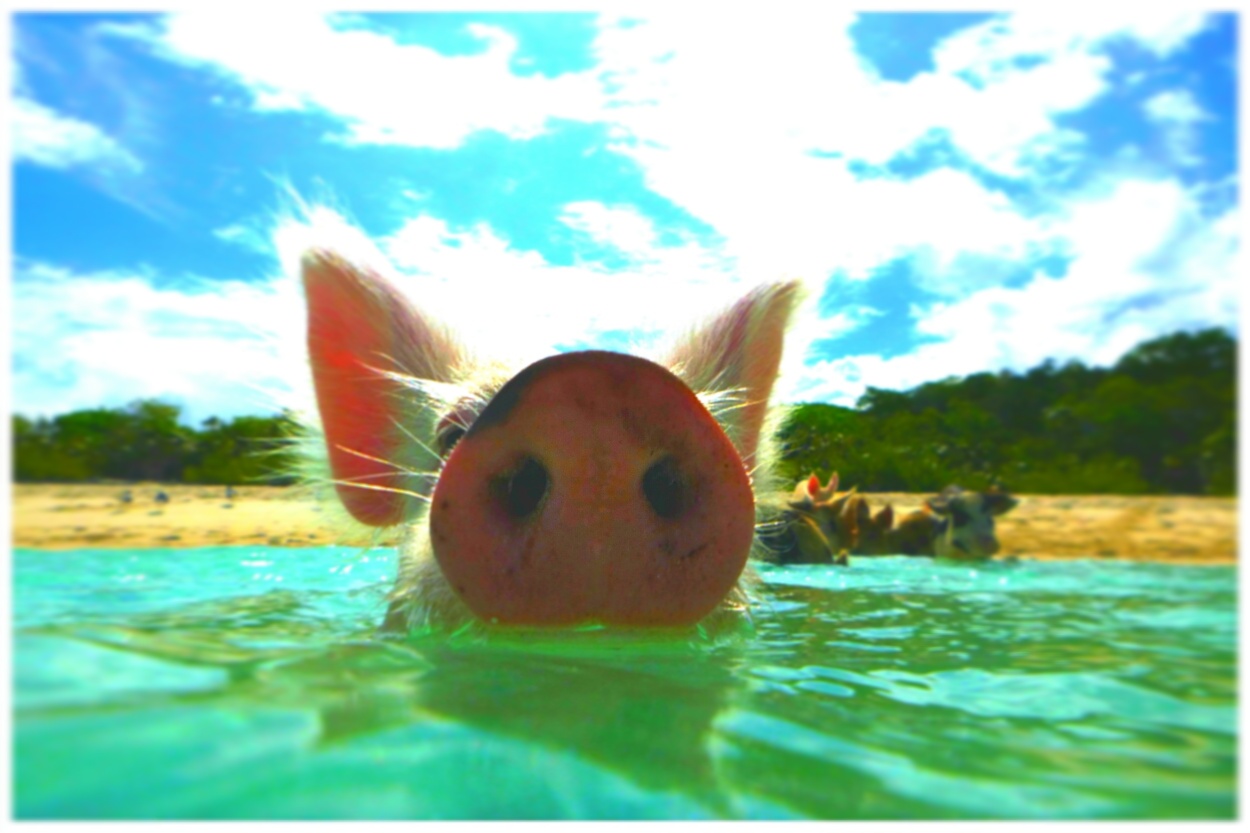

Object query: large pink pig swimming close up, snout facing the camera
[299,244,801,632]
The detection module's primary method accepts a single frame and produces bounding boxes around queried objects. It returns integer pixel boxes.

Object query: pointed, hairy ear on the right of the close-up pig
[665,280,800,470]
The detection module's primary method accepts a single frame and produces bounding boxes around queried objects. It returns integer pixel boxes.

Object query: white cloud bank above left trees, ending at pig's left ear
[11,261,308,422]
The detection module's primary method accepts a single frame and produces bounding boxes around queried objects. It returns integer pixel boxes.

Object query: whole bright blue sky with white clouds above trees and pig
[10,12,1238,423]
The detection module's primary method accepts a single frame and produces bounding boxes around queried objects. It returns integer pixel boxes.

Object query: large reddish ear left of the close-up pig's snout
[301,249,464,527]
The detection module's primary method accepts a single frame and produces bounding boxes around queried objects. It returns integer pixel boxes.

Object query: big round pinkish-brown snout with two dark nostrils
[429,351,755,627]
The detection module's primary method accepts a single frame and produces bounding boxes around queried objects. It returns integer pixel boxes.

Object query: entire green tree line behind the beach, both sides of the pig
[13,329,1236,495]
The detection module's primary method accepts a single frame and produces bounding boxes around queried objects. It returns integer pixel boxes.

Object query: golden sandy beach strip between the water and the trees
[13,483,1238,564]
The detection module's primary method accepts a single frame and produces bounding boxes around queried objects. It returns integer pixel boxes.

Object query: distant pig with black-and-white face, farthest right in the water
[881,485,1019,560]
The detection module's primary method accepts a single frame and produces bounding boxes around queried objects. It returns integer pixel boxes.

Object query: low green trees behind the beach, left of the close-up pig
[13,400,291,484]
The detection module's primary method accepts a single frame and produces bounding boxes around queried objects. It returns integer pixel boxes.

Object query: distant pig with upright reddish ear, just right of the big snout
[765,472,854,567]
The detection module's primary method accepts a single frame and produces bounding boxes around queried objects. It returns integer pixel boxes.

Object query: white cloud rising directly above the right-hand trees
[795,180,1239,405]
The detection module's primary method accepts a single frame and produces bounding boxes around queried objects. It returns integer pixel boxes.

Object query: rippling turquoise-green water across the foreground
[13,547,1238,819]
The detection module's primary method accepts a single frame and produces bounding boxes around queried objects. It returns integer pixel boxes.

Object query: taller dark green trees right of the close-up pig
[779,329,1236,495]
